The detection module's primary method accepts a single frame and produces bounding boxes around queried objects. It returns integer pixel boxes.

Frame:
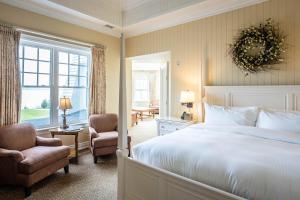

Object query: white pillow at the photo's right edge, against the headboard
[256,110,300,133]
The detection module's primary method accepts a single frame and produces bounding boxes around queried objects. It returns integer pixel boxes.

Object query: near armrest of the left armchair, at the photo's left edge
[0,148,24,185]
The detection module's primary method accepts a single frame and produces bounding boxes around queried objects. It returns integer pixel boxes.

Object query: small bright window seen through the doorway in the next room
[134,79,149,102]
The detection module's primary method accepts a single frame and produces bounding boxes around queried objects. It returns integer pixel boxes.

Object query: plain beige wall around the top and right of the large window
[0,3,120,144]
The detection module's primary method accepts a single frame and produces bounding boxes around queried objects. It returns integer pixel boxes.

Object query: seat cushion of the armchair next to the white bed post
[92,131,131,148]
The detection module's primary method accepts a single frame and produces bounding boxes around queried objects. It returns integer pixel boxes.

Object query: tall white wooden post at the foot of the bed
[117,33,128,200]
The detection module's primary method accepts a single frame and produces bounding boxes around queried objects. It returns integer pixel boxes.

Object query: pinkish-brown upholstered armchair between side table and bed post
[89,114,131,163]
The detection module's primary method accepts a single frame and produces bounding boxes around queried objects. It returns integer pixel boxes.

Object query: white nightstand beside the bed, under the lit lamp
[156,117,195,136]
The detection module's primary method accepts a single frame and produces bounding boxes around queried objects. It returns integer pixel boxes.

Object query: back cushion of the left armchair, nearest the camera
[0,124,36,151]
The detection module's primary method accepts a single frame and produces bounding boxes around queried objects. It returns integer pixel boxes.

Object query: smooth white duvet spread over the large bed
[132,124,300,200]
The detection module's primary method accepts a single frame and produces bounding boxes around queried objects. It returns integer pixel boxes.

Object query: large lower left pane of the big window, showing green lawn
[21,87,50,127]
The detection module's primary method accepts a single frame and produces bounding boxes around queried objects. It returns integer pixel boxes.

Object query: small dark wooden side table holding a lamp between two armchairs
[49,127,83,163]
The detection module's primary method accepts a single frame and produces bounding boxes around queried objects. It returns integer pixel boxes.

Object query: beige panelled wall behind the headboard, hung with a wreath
[126,0,300,119]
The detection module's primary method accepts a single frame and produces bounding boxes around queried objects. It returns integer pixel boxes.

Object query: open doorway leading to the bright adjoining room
[127,52,170,144]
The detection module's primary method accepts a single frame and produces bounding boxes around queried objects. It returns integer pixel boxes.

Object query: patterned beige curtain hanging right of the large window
[89,47,106,115]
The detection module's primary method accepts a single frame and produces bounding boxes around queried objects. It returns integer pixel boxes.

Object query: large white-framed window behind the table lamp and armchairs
[19,38,90,128]
